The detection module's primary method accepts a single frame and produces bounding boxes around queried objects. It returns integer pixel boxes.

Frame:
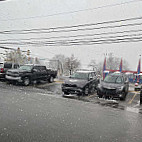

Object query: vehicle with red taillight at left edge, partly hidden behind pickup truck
[0,62,19,79]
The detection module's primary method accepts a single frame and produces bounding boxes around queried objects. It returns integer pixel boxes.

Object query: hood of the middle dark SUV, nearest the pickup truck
[64,78,88,87]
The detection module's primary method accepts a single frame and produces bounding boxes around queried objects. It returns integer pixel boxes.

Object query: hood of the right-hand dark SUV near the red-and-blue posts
[100,82,123,89]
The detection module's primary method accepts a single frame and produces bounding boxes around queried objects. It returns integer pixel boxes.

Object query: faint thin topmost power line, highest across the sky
[0,0,142,21]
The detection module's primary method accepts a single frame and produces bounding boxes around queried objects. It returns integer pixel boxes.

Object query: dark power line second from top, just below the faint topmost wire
[0,16,142,34]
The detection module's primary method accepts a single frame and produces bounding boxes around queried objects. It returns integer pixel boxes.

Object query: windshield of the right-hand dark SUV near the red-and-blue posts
[104,75,122,83]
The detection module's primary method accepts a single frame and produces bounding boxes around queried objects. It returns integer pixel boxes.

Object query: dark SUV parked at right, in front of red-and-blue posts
[97,73,129,100]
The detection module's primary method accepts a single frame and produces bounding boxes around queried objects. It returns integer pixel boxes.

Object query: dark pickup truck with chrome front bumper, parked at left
[5,64,57,86]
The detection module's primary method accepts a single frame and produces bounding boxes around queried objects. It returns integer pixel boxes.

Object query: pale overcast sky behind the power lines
[0,0,142,70]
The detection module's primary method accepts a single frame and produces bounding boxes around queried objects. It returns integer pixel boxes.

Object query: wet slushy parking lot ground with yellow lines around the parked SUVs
[30,80,142,113]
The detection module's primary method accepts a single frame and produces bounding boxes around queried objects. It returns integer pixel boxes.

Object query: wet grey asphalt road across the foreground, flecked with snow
[0,82,142,142]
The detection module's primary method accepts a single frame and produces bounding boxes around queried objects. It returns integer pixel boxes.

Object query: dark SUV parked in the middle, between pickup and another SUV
[62,70,99,96]
